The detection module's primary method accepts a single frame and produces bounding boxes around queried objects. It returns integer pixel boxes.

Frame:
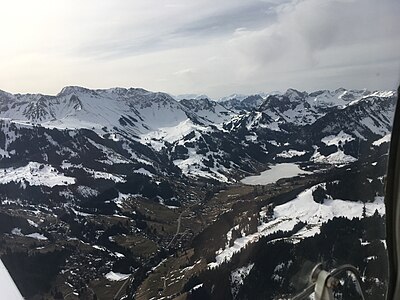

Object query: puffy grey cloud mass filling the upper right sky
[231,0,400,86]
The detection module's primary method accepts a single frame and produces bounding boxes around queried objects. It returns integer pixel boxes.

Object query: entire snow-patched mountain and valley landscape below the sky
[0,87,396,299]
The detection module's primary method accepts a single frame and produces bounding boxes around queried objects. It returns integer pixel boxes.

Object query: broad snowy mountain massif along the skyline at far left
[0,87,195,133]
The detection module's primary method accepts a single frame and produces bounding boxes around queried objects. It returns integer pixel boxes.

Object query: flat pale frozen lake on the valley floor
[241,163,312,185]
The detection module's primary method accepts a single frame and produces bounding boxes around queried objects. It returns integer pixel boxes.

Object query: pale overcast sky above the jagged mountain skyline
[0,0,400,98]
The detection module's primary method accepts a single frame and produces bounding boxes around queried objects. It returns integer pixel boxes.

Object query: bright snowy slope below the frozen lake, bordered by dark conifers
[208,184,385,268]
